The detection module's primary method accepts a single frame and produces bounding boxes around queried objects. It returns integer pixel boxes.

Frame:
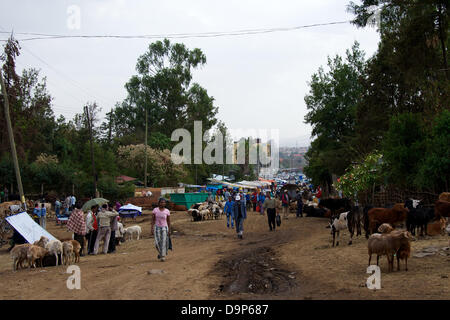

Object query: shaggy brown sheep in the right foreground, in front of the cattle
[367,230,412,272]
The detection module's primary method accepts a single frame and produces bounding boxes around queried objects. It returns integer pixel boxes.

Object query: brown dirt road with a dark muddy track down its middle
[0,212,450,300]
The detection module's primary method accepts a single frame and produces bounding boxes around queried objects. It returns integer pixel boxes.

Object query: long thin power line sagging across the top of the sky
[0,20,351,41]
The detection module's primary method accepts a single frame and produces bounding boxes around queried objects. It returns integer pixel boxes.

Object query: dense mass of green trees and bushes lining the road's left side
[0,38,225,199]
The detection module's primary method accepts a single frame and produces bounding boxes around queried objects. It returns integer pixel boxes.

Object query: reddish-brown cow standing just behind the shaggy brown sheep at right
[367,203,409,234]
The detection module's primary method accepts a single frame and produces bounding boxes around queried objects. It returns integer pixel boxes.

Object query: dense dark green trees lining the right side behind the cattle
[305,0,450,198]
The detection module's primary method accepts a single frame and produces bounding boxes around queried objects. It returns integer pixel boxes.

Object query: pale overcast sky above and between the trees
[0,0,379,147]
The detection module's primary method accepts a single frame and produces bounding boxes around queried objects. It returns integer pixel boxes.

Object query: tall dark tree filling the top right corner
[349,0,450,153]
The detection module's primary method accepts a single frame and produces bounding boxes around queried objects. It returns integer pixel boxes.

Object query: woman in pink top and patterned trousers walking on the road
[152,198,170,261]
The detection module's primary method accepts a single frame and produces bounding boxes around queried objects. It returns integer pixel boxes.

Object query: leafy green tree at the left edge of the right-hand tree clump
[304,42,365,185]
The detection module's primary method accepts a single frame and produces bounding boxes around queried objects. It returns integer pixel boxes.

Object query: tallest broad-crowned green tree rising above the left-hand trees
[113,39,217,142]
